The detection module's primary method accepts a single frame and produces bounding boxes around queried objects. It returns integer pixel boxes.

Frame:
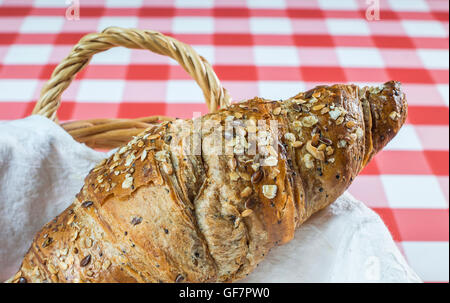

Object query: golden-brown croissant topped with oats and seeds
[9,81,407,283]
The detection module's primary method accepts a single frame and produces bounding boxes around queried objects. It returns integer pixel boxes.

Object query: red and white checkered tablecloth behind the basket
[0,0,449,282]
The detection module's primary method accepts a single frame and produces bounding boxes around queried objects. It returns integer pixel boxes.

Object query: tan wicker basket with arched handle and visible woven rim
[32,27,230,149]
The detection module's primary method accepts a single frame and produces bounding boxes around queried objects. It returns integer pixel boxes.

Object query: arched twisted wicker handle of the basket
[33,27,230,121]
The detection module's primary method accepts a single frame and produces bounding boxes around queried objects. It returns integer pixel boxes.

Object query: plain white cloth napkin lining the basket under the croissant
[0,116,421,282]
